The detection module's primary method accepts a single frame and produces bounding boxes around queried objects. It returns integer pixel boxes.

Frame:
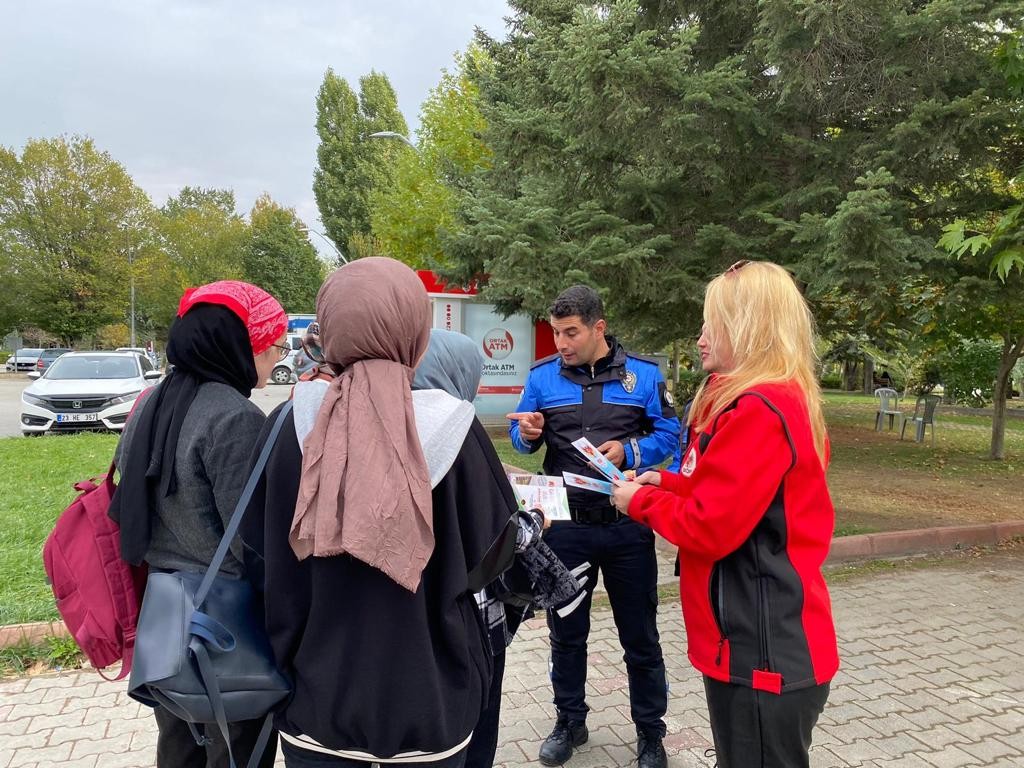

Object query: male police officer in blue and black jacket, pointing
[508,286,679,768]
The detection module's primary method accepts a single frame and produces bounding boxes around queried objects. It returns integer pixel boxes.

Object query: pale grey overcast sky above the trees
[0,0,508,257]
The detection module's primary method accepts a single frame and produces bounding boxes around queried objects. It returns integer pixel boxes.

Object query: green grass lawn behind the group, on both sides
[0,393,1024,625]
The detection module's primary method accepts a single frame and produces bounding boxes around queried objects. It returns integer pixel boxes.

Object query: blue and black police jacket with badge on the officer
[509,336,679,509]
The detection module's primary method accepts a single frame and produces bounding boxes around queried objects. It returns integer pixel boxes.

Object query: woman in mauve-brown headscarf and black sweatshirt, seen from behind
[242,258,516,768]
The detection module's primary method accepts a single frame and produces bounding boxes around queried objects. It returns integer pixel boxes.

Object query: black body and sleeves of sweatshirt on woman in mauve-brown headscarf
[236,405,516,762]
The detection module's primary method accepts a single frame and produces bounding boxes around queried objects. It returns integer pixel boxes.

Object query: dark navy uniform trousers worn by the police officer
[544,517,669,738]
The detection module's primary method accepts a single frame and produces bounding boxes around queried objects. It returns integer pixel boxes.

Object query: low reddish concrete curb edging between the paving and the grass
[8,520,1024,648]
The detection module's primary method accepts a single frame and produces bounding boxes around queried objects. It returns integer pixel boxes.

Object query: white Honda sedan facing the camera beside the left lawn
[22,352,163,435]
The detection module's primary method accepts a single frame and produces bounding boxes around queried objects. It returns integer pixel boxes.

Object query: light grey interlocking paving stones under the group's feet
[0,552,1024,768]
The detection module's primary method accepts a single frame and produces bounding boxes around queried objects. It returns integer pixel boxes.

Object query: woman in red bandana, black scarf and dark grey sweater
[110,281,288,768]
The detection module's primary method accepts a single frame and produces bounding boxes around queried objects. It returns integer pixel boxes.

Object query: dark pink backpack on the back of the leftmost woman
[43,463,146,680]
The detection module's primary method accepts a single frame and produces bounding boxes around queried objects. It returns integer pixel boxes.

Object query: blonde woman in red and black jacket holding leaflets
[612,261,839,768]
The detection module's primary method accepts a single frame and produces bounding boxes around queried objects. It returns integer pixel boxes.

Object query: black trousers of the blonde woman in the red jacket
[705,676,828,768]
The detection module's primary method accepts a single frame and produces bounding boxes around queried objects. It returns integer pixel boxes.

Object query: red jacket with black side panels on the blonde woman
[629,383,839,693]
